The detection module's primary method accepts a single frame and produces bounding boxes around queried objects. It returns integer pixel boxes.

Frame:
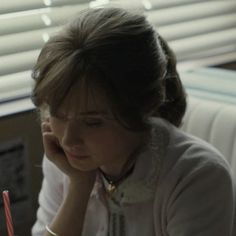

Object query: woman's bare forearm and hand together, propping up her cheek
[42,119,96,236]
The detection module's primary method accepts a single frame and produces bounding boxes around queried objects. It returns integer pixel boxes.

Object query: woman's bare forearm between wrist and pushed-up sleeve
[45,183,91,236]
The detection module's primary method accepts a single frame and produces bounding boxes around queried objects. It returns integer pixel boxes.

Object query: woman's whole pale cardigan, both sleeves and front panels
[32,118,236,236]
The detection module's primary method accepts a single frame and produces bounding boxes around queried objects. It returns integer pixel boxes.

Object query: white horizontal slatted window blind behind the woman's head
[0,0,236,112]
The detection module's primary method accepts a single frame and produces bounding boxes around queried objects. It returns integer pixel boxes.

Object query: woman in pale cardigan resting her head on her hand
[32,8,234,236]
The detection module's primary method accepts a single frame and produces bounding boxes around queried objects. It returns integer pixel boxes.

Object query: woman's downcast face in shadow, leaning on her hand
[50,84,142,175]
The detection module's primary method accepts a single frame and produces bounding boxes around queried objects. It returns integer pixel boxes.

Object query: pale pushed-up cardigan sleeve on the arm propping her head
[32,157,63,236]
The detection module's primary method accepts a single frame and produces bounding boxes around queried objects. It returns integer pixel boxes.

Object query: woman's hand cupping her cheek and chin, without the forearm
[41,118,96,184]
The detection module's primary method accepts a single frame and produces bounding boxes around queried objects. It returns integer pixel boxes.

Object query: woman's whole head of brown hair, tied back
[32,8,186,130]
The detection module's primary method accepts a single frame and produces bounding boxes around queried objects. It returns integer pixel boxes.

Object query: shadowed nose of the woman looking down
[62,120,84,149]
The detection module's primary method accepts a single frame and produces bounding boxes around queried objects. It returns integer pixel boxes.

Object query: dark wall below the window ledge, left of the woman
[0,111,43,236]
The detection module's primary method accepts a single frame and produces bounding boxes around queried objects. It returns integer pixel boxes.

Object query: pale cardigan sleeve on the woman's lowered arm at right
[158,147,235,236]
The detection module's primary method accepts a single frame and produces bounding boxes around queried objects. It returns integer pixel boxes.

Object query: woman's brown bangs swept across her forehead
[32,48,101,117]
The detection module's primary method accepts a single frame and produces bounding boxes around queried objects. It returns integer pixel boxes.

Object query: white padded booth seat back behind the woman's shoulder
[182,95,236,180]
